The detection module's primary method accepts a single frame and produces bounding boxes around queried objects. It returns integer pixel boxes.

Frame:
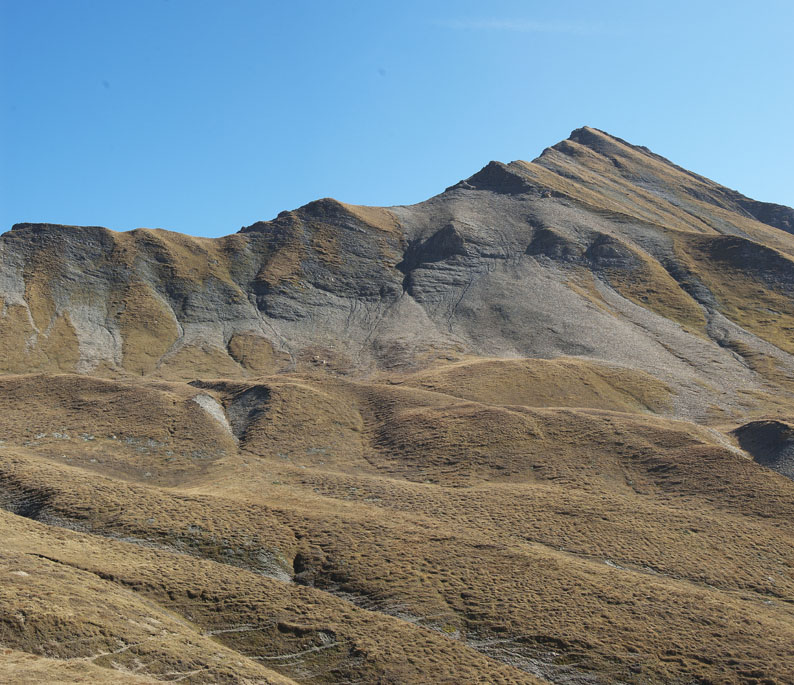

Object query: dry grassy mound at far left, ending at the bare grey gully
[0,375,236,483]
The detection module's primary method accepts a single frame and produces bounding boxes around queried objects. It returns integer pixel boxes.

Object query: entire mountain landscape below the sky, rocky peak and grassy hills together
[0,128,794,685]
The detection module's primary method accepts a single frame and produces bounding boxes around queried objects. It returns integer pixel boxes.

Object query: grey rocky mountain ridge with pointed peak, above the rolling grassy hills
[0,128,794,412]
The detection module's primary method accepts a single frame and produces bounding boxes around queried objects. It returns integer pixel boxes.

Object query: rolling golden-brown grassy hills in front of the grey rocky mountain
[0,368,794,683]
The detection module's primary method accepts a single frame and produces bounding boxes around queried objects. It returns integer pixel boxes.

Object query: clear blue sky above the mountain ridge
[0,0,794,236]
